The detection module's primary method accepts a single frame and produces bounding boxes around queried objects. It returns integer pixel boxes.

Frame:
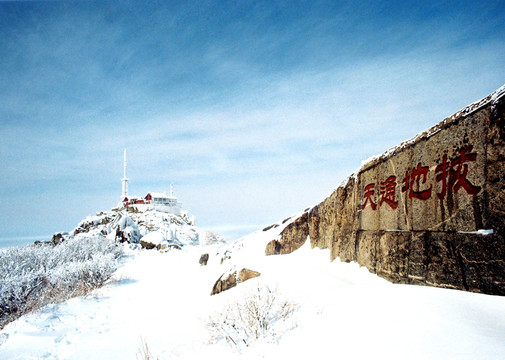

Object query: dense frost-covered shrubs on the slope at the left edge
[0,236,124,329]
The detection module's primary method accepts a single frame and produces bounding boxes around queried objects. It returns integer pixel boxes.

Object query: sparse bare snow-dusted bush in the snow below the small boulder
[206,287,296,351]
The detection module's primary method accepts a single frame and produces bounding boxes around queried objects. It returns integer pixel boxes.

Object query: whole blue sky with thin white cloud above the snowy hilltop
[0,1,505,242]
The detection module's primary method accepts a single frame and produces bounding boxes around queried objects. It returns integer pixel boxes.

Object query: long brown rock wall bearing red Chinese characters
[266,86,505,295]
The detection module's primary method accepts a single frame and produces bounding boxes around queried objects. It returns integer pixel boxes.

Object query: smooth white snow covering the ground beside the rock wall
[0,226,505,359]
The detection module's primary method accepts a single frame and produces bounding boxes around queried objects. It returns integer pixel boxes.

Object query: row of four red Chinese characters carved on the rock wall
[361,145,481,210]
